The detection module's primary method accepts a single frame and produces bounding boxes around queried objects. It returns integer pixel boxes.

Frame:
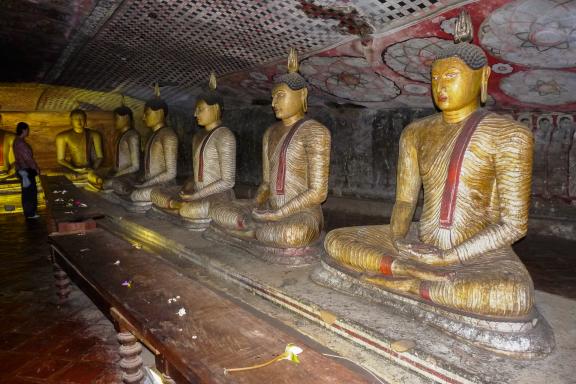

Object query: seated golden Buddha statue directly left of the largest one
[212,50,330,263]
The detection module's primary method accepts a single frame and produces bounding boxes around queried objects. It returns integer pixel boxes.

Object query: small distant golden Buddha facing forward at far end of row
[56,109,103,188]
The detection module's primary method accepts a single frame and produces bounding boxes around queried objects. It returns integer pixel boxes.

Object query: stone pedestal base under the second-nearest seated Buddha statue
[202,225,324,265]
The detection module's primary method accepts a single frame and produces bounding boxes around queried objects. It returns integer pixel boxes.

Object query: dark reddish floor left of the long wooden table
[0,214,121,384]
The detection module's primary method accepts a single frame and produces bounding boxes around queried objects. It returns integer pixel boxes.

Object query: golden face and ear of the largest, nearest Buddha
[432,57,490,112]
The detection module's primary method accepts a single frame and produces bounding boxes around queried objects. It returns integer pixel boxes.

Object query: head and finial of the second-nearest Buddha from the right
[272,48,308,121]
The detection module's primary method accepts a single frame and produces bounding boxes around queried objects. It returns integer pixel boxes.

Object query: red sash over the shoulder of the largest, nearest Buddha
[440,109,488,228]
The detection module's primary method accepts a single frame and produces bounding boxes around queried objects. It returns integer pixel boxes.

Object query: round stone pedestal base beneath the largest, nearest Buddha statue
[311,254,555,359]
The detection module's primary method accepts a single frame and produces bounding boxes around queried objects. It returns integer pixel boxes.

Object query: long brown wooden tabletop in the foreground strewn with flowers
[50,229,371,383]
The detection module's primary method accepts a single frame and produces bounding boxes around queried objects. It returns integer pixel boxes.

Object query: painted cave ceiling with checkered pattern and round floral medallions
[0,0,576,111]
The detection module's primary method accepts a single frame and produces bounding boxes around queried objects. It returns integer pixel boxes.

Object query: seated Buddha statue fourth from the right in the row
[125,85,178,208]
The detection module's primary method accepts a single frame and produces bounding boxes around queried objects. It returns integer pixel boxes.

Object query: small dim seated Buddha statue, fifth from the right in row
[100,105,141,195]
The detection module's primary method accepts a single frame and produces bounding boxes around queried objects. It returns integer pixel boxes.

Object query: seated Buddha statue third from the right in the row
[151,73,236,230]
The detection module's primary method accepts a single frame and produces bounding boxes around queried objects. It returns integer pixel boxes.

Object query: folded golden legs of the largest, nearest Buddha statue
[325,225,534,316]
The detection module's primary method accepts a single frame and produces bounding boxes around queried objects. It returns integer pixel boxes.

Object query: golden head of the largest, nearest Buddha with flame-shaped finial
[431,12,490,117]
